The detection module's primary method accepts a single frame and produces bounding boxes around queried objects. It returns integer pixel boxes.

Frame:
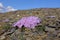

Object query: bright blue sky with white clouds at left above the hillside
[0,0,60,11]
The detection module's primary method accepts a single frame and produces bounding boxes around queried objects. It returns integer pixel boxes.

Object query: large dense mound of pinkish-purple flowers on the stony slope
[13,16,41,28]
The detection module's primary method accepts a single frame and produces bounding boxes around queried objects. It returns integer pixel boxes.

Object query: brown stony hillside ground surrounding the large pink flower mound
[0,8,60,40]
